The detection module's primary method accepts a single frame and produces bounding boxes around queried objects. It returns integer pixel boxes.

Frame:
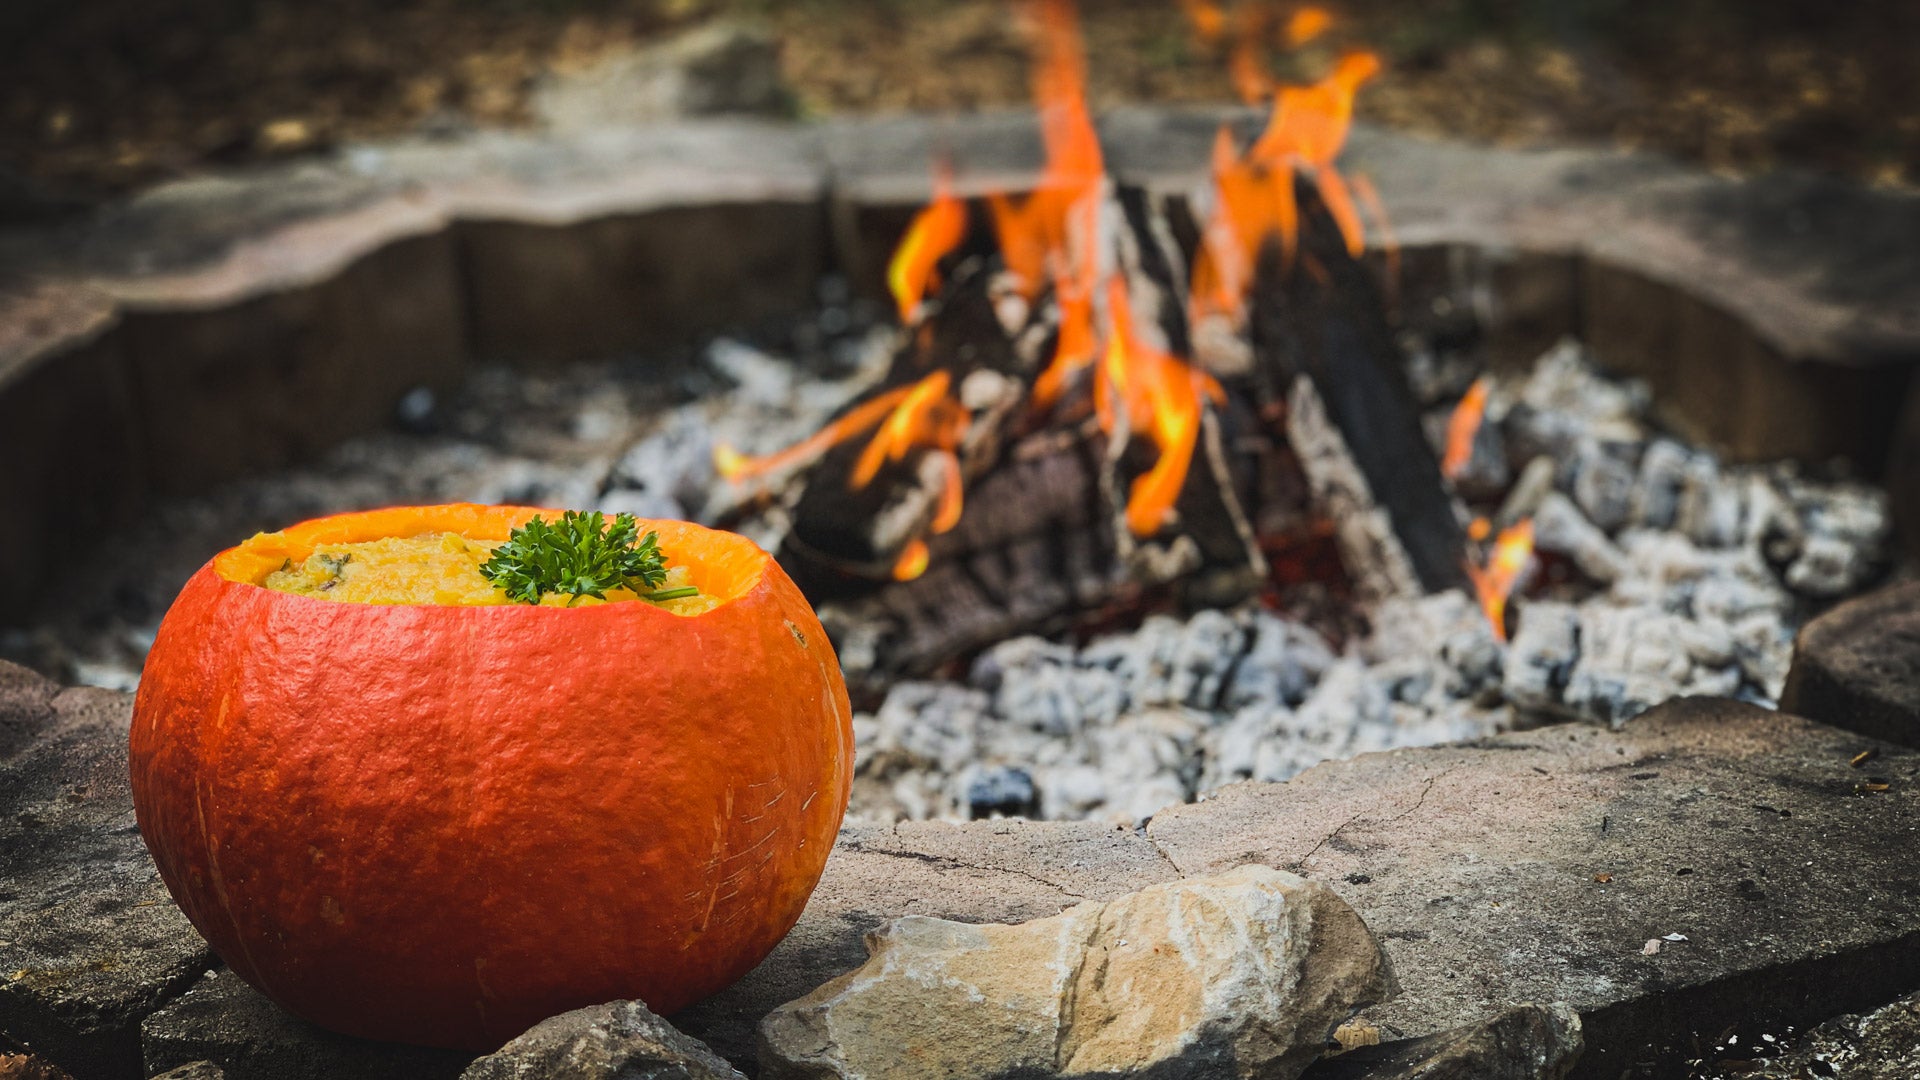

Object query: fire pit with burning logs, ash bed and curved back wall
[0,6,1920,1074]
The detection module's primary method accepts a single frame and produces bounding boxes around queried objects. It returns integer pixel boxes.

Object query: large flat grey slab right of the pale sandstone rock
[1148,698,1920,1080]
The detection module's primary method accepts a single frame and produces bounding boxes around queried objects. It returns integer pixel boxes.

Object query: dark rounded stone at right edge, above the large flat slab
[1780,582,1920,746]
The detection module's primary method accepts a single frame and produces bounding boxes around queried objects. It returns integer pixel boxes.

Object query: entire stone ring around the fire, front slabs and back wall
[0,111,1920,1080]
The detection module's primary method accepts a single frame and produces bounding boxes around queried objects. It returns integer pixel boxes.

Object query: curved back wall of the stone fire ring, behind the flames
[0,108,1920,625]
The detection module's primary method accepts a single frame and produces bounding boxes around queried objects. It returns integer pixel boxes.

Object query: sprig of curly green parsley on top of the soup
[480,509,675,603]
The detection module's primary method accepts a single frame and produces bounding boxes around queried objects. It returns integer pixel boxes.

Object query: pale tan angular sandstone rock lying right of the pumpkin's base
[760,867,1392,1080]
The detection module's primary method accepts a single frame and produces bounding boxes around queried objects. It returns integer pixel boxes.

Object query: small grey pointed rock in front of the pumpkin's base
[461,1001,745,1080]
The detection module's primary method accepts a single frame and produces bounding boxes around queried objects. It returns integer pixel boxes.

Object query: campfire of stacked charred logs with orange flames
[714,0,1489,703]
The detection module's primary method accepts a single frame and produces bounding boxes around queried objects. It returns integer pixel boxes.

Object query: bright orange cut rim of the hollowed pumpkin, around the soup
[207,502,774,619]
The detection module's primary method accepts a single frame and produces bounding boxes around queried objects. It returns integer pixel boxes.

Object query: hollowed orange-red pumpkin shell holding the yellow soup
[131,505,852,1051]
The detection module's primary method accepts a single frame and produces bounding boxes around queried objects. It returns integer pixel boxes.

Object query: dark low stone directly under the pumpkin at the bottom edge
[140,970,474,1080]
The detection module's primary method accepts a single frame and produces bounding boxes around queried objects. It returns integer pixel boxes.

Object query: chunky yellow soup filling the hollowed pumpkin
[261,532,718,615]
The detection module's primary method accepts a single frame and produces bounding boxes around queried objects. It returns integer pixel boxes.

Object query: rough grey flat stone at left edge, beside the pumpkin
[0,663,213,1080]
